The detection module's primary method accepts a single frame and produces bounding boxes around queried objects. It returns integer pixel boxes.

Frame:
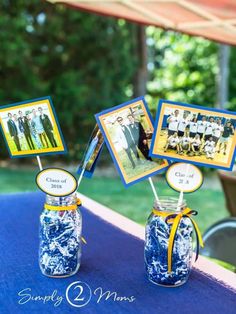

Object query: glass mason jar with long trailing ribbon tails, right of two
[144,198,193,287]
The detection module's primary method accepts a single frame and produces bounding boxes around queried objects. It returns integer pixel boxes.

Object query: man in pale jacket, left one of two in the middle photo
[117,117,140,168]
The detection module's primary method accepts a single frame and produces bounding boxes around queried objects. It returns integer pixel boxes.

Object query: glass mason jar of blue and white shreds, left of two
[39,193,82,277]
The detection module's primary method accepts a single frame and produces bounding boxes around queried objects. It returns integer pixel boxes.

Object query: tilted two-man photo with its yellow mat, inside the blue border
[95,101,168,183]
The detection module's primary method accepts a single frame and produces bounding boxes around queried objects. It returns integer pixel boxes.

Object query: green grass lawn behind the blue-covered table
[0,169,229,232]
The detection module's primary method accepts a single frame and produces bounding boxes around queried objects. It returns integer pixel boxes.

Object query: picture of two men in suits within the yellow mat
[105,107,162,177]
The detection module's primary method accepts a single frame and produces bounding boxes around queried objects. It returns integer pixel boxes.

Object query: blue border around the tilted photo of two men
[95,96,170,188]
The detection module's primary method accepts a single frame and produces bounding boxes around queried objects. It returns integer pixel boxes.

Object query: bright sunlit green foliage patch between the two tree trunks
[147,27,218,109]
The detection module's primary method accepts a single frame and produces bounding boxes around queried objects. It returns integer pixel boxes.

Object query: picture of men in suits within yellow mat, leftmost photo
[6,107,58,152]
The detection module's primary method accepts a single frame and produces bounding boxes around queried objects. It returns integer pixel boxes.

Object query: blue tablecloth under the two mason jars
[0,193,236,314]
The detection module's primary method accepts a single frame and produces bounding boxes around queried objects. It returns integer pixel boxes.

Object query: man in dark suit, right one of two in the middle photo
[127,114,152,161]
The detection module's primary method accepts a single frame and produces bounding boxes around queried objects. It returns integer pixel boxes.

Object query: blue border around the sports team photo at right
[149,99,236,171]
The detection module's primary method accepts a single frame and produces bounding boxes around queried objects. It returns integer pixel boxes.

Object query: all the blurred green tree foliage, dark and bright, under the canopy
[0,0,236,164]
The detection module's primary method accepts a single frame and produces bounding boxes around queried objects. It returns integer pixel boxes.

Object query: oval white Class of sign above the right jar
[166,162,203,193]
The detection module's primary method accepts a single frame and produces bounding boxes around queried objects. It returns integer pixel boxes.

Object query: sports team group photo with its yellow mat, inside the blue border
[152,104,236,167]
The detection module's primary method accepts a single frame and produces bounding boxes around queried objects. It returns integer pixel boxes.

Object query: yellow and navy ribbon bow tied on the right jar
[152,207,204,273]
